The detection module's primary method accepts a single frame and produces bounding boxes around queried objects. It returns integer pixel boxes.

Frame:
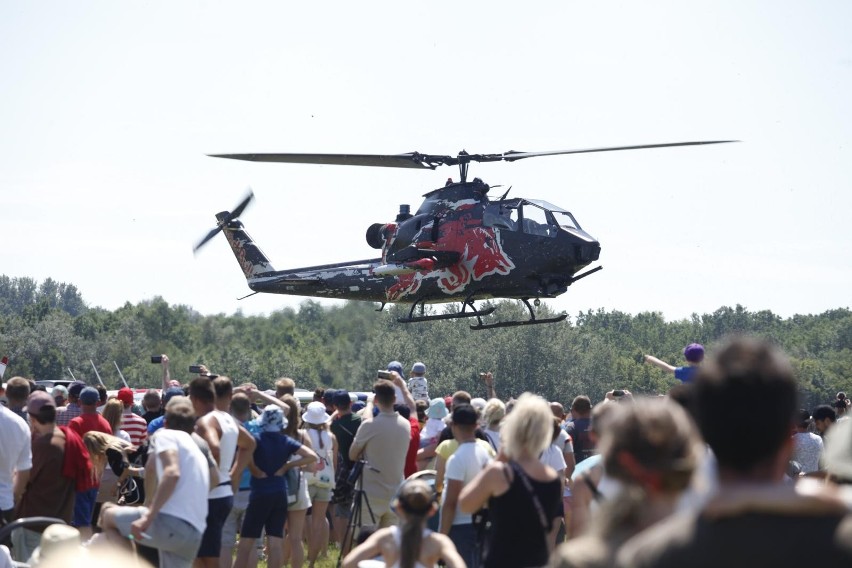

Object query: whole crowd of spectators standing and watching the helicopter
[0,338,852,568]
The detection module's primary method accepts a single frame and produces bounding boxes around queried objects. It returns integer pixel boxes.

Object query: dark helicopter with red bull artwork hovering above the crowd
[193,140,734,330]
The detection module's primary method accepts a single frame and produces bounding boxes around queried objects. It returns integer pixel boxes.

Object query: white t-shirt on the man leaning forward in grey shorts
[151,428,210,533]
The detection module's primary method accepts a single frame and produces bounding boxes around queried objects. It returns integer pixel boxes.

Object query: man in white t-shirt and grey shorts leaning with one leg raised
[101,401,210,568]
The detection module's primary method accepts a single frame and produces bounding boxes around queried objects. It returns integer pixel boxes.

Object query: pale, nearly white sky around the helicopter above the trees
[0,0,852,319]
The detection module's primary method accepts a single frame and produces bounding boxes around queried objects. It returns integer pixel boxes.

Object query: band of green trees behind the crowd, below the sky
[0,276,852,408]
